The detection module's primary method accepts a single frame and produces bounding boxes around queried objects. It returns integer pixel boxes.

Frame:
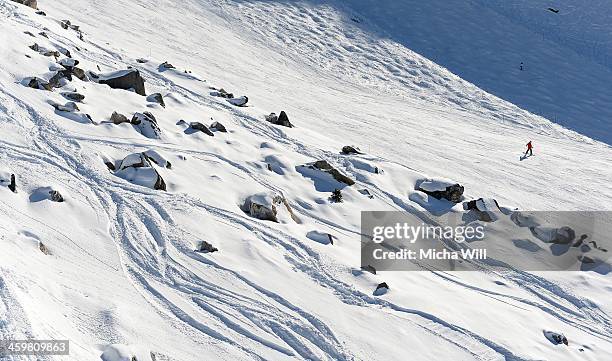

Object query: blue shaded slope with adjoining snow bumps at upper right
[221,1,612,144]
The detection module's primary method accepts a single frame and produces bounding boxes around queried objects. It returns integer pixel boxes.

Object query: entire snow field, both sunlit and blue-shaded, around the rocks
[0,0,612,361]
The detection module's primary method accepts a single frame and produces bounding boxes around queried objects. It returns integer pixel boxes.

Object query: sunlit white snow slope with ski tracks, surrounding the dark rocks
[0,1,612,360]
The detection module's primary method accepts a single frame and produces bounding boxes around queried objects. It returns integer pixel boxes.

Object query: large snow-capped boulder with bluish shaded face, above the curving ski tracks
[115,150,171,191]
